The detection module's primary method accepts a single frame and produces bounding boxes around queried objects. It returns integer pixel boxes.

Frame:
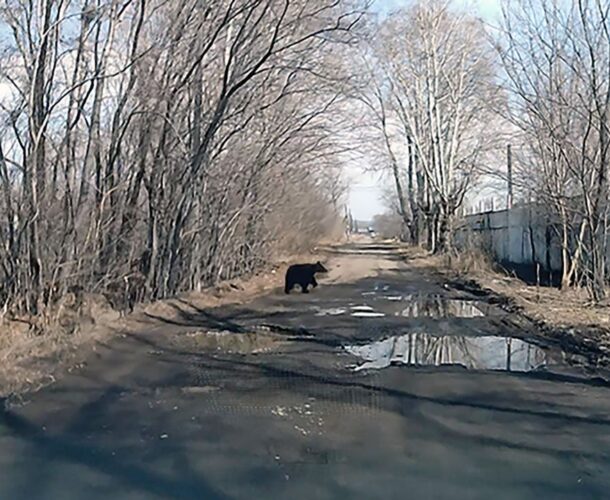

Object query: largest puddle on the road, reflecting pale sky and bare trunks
[345,333,550,372]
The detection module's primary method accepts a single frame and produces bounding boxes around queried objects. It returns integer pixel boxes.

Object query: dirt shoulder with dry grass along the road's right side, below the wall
[408,249,610,367]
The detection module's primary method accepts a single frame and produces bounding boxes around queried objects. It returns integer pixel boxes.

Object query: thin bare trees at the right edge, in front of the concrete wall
[498,0,610,301]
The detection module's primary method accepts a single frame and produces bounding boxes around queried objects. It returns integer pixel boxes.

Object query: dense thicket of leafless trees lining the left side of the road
[0,0,362,313]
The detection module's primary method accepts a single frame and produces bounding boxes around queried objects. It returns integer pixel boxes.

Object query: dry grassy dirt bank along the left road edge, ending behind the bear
[0,251,346,397]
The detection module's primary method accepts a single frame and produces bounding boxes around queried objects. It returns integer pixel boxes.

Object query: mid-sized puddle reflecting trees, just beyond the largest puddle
[394,295,485,318]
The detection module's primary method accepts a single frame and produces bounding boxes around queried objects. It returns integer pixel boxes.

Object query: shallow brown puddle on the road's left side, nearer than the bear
[183,330,289,354]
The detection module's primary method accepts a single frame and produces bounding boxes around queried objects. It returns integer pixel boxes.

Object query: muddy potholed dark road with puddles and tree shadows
[0,245,610,499]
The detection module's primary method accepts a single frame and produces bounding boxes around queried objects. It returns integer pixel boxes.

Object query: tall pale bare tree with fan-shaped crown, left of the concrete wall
[352,1,497,252]
